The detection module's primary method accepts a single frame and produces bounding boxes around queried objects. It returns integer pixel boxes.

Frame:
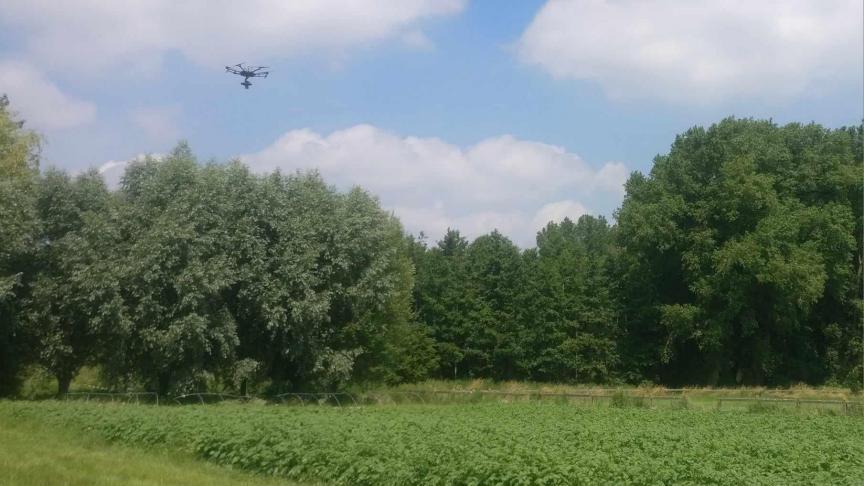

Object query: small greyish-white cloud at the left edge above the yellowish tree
[0,61,96,130]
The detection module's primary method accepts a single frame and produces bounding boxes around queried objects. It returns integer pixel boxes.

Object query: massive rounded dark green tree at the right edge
[618,119,862,384]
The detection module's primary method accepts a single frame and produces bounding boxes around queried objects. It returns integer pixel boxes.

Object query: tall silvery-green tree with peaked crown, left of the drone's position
[103,144,238,394]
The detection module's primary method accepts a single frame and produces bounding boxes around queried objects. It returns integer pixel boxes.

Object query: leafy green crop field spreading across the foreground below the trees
[0,401,864,484]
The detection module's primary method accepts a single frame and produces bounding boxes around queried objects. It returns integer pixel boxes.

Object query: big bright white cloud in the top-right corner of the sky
[517,0,864,104]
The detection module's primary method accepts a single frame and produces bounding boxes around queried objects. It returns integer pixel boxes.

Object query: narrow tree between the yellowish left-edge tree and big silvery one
[27,169,118,394]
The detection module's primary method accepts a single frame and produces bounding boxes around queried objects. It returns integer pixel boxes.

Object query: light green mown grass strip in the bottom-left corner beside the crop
[0,408,294,486]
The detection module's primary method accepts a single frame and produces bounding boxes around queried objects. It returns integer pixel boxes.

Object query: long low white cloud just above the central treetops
[241,125,628,246]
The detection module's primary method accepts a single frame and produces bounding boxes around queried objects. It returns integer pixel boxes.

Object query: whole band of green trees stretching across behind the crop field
[0,98,864,395]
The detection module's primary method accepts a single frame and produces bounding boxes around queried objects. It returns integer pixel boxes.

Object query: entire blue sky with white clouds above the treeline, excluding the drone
[0,0,864,247]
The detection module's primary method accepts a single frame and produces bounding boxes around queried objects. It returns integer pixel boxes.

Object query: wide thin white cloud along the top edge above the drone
[0,0,465,72]
